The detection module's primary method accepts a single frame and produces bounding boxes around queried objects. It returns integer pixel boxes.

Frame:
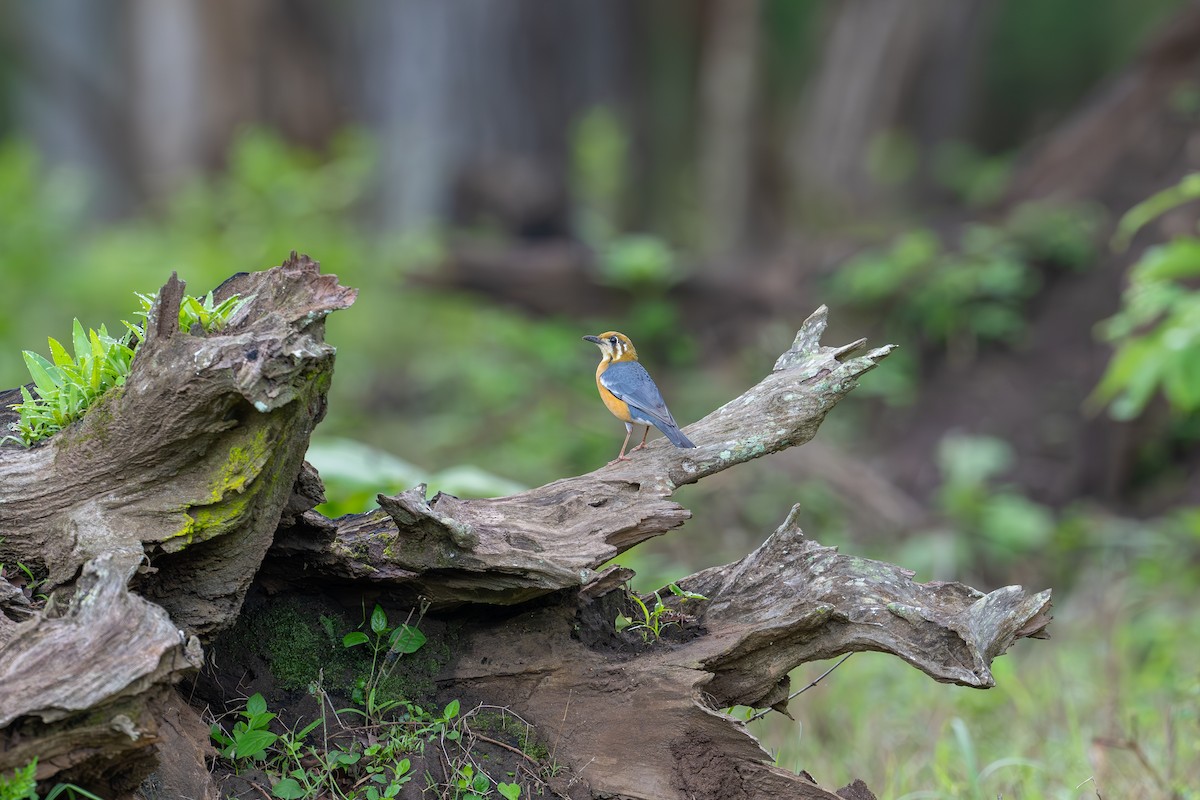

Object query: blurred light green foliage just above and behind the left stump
[0,130,384,385]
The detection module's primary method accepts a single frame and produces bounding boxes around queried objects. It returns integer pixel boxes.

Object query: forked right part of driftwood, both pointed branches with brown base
[264,303,1050,798]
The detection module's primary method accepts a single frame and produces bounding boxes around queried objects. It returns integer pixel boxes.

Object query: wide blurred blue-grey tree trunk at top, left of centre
[359,0,629,234]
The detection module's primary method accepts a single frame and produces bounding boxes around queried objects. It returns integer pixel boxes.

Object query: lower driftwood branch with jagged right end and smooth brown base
[439,509,1050,800]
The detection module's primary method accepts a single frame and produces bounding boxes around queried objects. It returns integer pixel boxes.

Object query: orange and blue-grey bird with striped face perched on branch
[583,331,696,467]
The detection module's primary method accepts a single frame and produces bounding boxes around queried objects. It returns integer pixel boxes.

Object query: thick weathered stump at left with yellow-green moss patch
[0,253,356,786]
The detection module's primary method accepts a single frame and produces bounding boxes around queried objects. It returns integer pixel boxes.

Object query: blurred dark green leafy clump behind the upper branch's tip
[829,205,1098,345]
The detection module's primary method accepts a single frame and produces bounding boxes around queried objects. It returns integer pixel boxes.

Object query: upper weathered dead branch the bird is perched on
[266,306,892,606]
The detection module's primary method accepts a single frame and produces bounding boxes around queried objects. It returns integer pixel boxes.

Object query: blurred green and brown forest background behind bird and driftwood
[0,0,1200,799]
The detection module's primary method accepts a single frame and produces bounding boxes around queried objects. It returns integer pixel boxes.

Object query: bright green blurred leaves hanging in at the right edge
[1090,174,1200,420]
